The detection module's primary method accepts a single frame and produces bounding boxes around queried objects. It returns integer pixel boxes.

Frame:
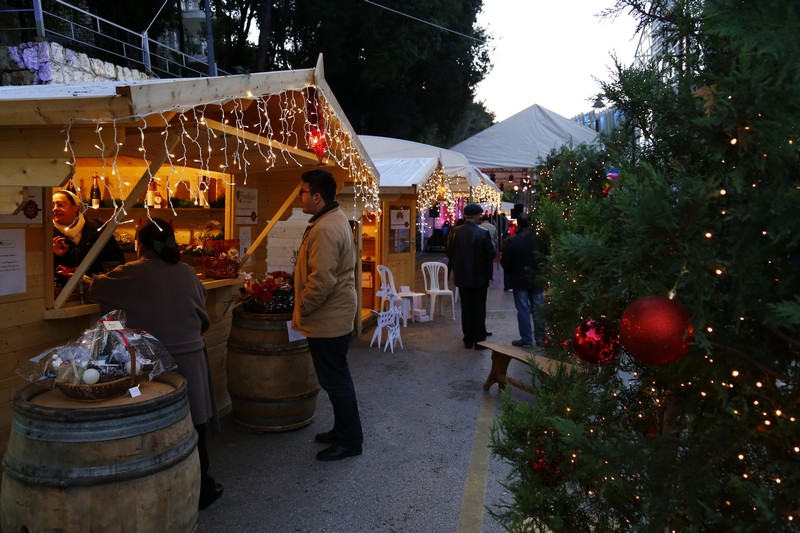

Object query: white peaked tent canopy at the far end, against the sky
[450,105,597,168]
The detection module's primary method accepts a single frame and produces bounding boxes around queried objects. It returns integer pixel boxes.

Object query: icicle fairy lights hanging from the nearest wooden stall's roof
[64,86,380,228]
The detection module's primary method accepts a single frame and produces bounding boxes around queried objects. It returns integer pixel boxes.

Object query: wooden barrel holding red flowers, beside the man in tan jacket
[227,307,319,433]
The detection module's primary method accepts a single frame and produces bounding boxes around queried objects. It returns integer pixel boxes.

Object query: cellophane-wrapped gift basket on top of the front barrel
[16,311,176,401]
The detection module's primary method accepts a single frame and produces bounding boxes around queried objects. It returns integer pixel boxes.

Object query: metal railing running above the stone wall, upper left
[3,0,228,78]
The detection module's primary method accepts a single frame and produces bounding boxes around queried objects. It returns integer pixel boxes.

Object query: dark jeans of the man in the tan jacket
[308,334,364,447]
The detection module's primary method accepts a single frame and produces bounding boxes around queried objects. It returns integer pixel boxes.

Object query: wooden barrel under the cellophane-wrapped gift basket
[0,372,200,533]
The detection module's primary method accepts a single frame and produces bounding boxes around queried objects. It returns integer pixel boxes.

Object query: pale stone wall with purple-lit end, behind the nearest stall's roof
[0,41,150,85]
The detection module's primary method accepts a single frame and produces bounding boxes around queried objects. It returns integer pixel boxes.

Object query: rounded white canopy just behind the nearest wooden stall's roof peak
[358,135,499,192]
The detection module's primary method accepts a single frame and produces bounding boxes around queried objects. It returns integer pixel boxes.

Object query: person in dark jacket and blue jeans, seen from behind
[500,214,546,348]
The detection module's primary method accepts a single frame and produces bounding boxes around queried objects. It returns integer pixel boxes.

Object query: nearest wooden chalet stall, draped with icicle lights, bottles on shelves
[0,57,379,453]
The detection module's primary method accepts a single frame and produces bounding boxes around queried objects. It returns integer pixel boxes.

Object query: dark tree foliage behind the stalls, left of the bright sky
[244,0,493,146]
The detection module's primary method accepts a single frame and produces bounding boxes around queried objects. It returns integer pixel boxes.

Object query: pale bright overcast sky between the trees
[477,0,638,121]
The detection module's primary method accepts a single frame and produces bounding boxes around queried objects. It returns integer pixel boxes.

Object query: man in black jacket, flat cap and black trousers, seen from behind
[447,204,495,349]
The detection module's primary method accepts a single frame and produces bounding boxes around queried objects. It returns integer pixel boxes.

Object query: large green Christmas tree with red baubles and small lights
[490,0,800,532]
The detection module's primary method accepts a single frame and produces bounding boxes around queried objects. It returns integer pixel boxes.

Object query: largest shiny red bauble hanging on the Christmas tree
[619,296,694,365]
